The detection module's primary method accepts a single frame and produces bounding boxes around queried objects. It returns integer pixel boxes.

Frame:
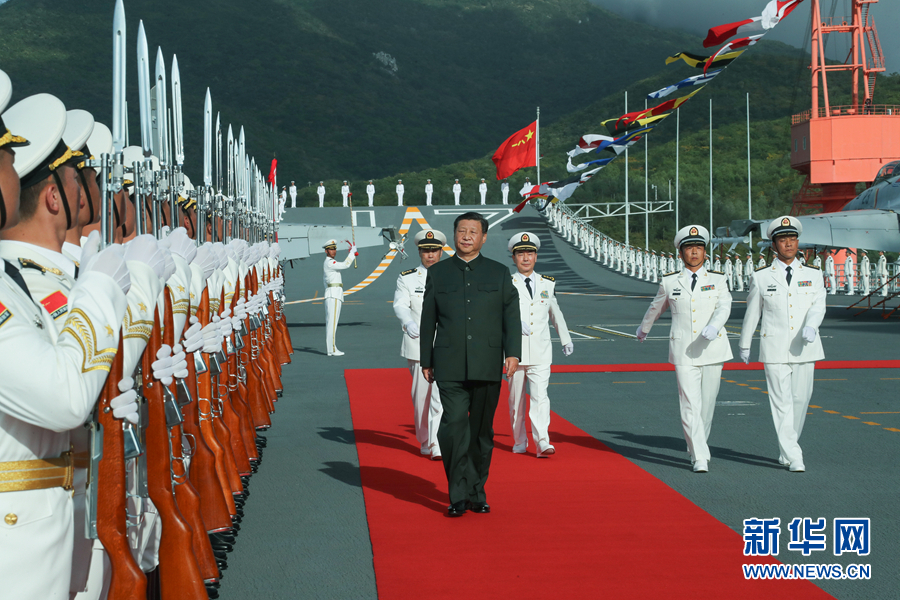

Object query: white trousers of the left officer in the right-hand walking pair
[675,363,722,461]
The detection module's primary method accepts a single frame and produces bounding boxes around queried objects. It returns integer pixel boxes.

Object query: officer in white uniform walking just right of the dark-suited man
[507,232,575,458]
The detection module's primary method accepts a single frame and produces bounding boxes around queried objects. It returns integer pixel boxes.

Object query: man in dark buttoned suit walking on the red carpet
[419,212,522,517]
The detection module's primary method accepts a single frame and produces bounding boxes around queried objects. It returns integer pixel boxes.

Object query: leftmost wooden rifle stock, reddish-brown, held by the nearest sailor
[96,337,147,600]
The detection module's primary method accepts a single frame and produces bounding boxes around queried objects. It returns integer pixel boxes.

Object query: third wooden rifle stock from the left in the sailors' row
[163,288,219,582]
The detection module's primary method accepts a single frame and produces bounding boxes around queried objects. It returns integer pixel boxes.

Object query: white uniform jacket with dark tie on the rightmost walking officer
[740,260,825,363]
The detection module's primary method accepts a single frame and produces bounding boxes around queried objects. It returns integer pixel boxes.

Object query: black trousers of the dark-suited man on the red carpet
[437,381,500,504]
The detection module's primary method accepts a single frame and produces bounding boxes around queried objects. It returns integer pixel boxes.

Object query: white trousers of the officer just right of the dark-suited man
[508,364,550,450]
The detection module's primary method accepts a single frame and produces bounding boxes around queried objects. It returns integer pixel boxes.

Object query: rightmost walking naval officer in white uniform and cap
[740,216,826,473]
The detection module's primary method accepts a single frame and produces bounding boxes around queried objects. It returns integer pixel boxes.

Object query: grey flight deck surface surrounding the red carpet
[221,206,900,600]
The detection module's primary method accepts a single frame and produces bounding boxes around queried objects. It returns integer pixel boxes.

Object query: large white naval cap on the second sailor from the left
[3,94,84,189]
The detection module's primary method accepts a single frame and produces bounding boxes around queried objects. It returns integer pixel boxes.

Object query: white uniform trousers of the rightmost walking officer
[764,362,816,463]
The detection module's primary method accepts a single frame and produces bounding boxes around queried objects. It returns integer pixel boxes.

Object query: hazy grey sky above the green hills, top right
[590,0,900,74]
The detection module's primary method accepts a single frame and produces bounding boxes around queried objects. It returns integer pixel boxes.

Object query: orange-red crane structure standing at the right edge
[791,0,900,215]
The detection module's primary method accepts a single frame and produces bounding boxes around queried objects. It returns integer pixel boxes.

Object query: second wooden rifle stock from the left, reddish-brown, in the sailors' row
[142,310,208,600]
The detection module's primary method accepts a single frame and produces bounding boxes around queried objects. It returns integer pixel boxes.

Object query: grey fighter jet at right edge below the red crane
[728,160,900,252]
